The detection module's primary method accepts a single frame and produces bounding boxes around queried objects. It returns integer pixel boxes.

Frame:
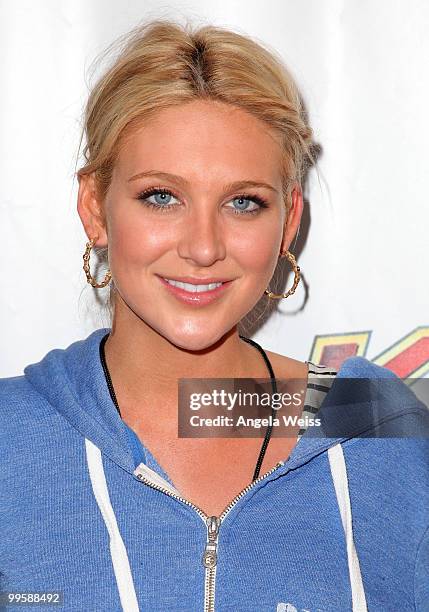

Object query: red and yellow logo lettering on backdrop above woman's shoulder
[309,326,429,378]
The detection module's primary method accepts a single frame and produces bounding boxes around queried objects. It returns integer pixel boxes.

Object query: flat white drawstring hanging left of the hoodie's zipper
[85,438,139,612]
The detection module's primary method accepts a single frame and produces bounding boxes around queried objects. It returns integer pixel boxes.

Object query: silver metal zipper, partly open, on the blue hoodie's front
[134,461,284,612]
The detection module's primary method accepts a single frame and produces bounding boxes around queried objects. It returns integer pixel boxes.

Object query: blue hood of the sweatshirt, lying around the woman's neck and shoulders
[24,327,429,472]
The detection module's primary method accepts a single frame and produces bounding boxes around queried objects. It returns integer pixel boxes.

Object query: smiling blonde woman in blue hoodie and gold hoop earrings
[0,21,429,612]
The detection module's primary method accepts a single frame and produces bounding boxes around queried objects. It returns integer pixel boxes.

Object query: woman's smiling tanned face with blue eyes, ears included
[79,101,302,350]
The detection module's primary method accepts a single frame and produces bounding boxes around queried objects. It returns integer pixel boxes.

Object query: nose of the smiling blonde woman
[178,205,226,266]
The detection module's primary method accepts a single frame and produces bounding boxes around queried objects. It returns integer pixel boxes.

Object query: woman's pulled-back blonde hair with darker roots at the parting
[77,19,315,332]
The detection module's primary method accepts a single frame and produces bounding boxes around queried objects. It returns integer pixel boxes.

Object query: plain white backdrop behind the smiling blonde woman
[0,0,429,376]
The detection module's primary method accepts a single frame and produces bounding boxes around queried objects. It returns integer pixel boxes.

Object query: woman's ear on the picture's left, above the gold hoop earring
[77,173,107,247]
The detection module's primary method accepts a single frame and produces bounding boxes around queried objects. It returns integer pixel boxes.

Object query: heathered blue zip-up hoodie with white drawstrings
[0,328,429,612]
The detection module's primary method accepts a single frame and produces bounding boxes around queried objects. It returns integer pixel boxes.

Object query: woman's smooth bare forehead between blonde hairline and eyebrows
[113,100,282,181]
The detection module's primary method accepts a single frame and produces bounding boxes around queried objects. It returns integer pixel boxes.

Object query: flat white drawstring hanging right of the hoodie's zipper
[328,444,367,612]
